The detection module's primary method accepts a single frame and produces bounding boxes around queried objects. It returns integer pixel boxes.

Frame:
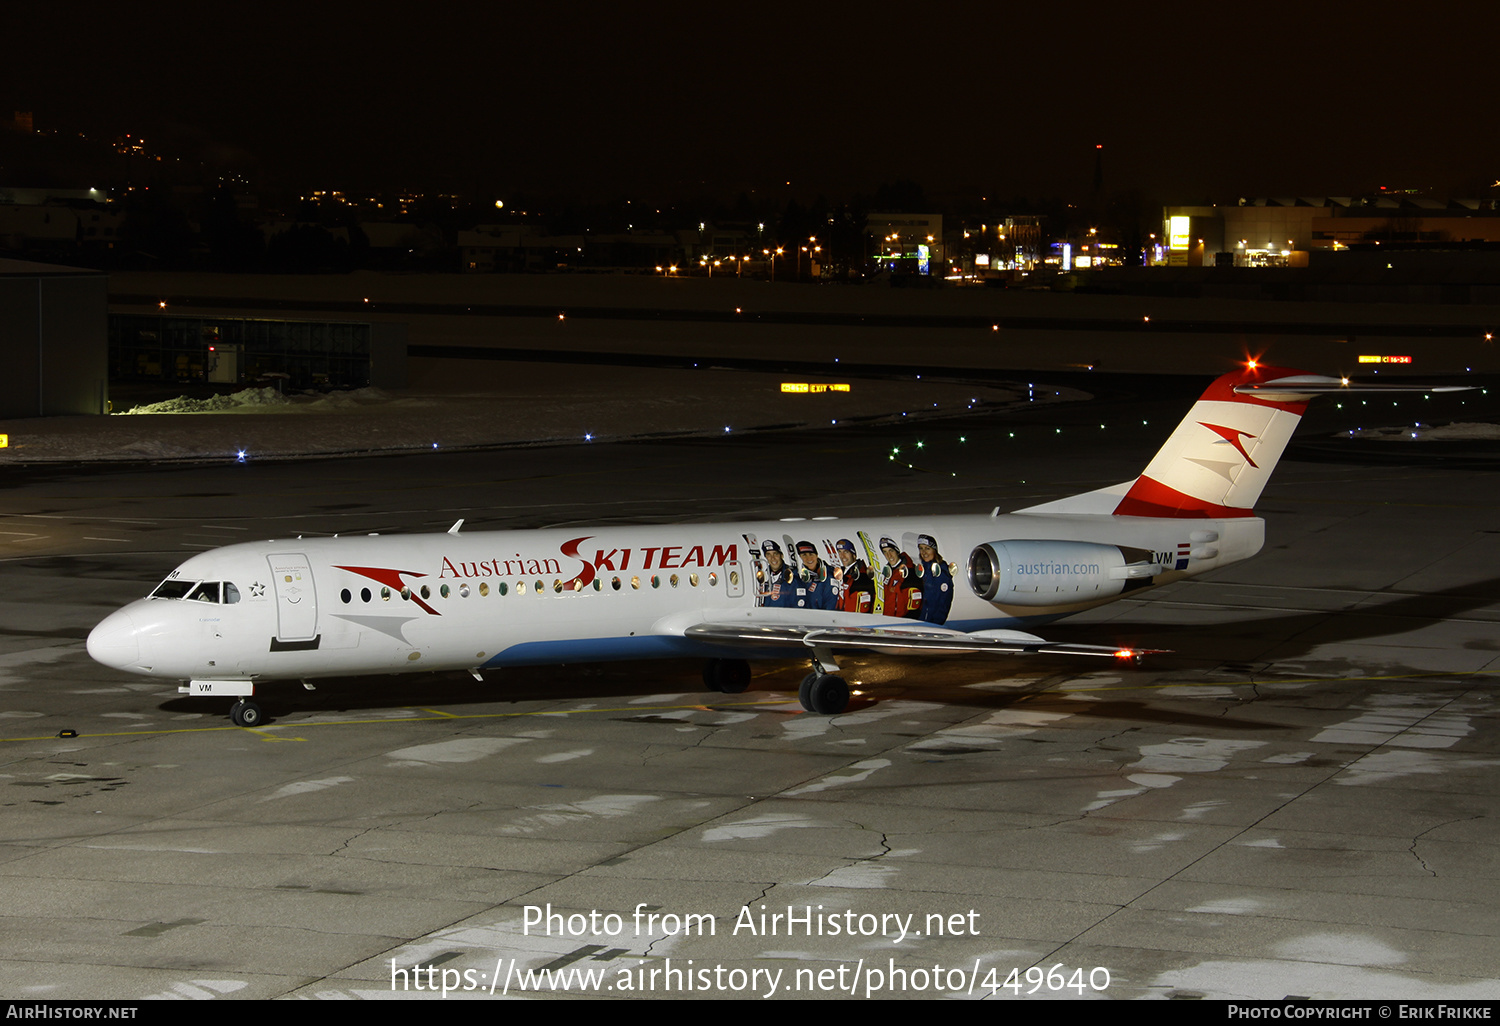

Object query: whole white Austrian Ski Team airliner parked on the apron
[89,362,1446,726]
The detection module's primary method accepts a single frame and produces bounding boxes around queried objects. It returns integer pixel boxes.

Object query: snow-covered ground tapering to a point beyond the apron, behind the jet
[0,370,1088,467]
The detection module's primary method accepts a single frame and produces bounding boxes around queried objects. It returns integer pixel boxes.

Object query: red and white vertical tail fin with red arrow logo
[1115,363,1337,518]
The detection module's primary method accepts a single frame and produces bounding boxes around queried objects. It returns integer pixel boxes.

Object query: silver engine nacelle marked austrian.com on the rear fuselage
[969,540,1139,606]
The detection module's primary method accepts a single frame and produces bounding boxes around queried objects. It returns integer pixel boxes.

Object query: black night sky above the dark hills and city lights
[11,2,1500,203]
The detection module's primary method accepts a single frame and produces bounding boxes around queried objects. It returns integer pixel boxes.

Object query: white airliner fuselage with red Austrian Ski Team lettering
[89,513,1263,681]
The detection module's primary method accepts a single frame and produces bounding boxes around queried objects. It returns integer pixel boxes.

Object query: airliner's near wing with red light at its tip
[681,609,1169,659]
